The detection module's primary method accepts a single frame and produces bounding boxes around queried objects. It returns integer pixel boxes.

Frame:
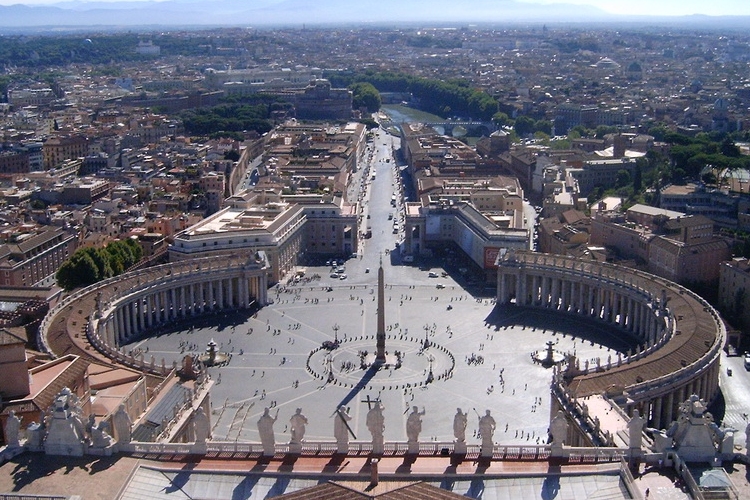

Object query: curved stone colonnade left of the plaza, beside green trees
[39,252,269,372]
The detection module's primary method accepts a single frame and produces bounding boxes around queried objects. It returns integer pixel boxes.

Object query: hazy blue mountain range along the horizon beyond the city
[0,0,750,32]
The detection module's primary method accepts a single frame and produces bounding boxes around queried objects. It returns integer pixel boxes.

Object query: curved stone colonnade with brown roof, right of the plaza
[497,252,726,428]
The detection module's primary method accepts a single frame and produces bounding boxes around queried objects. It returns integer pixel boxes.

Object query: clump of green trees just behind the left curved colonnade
[55,239,143,290]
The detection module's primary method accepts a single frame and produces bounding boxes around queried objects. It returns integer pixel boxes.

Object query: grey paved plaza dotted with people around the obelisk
[127,259,632,444]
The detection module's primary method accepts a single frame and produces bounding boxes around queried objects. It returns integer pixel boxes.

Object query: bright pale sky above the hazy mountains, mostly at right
[0,0,750,16]
